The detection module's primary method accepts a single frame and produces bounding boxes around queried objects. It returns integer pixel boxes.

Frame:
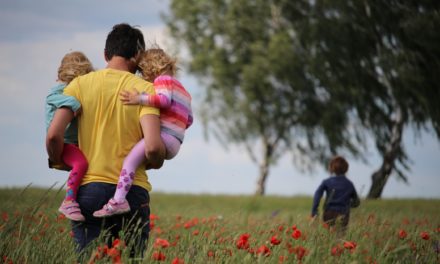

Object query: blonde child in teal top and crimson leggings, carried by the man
[46,51,93,221]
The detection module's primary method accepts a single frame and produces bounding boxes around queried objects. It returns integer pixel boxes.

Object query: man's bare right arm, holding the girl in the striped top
[140,115,165,169]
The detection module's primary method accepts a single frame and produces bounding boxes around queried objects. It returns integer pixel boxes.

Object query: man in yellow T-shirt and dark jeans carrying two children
[46,24,165,256]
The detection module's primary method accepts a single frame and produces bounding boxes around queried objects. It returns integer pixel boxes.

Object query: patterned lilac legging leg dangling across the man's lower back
[113,139,146,203]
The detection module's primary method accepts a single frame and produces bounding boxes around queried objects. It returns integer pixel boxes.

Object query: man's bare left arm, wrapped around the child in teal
[46,107,74,164]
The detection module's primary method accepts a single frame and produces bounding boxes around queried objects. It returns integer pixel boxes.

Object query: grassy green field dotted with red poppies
[0,188,440,264]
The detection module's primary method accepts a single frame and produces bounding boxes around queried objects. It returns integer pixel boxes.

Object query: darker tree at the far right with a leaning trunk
[309,0,440,199]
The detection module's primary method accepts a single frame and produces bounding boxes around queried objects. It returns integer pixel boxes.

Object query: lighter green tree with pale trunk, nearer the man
[165,0,362,195]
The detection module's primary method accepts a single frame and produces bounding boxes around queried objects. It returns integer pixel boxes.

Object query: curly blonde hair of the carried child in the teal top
[58,51,93,84]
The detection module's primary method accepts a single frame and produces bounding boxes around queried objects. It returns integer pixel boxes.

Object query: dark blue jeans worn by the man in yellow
[72,182,150,257]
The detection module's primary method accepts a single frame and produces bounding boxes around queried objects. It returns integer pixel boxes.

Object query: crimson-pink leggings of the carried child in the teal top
[62,144,89,201]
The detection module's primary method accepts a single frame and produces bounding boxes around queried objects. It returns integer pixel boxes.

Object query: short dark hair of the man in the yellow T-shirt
[104,23,145,60]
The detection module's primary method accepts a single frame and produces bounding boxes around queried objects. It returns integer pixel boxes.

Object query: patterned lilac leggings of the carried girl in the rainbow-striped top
[113,133,181,202]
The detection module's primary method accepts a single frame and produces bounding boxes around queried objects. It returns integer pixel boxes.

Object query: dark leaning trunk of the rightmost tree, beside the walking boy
[367,107,404,199]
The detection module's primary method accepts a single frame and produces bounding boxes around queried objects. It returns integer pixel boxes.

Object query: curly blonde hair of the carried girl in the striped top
[138,48,177,82]
